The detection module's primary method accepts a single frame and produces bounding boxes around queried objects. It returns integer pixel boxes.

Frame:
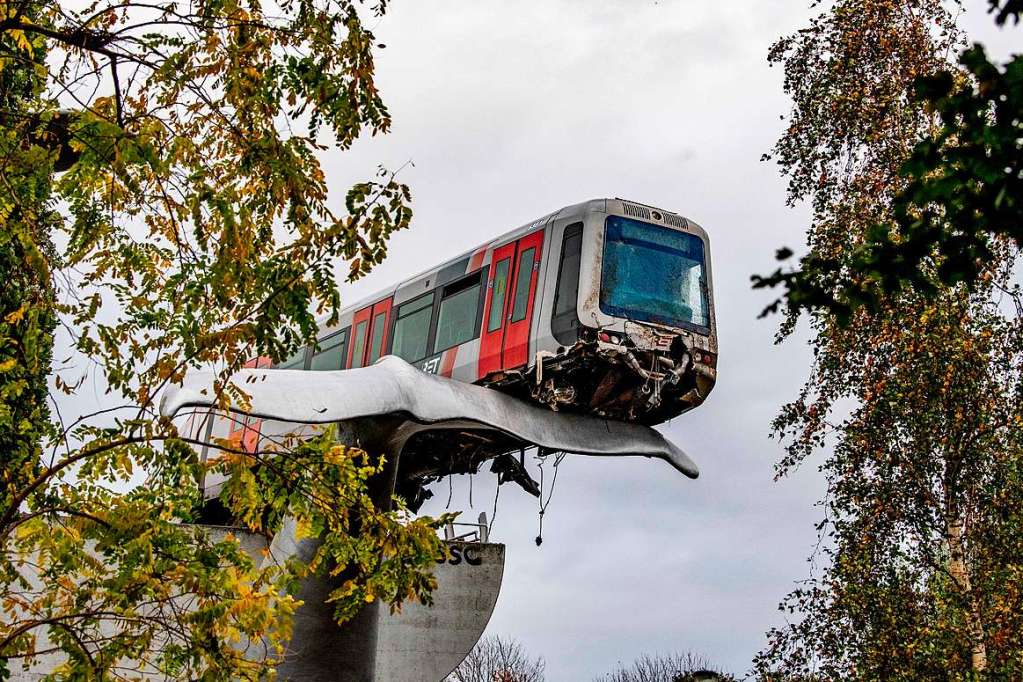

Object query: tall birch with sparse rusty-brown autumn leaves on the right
[756,0,1023,680]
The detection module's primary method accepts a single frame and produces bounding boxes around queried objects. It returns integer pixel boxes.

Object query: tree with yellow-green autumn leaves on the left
[0,0,448,679]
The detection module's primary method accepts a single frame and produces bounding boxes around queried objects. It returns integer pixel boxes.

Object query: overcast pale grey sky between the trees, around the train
[313,0,1023,681]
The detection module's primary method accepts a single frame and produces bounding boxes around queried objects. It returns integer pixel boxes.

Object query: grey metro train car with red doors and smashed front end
[259,198,717,424]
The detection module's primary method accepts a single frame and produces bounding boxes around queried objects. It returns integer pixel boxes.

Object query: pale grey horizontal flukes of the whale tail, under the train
[160,356,700,479]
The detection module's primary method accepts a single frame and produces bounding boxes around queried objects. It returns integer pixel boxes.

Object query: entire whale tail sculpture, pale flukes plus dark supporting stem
[161,356,699,682]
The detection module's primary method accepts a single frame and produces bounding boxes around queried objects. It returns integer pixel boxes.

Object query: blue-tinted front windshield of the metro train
[601,216,710,333]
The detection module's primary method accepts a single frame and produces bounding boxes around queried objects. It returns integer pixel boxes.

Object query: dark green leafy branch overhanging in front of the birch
[753,0,1023,320]
